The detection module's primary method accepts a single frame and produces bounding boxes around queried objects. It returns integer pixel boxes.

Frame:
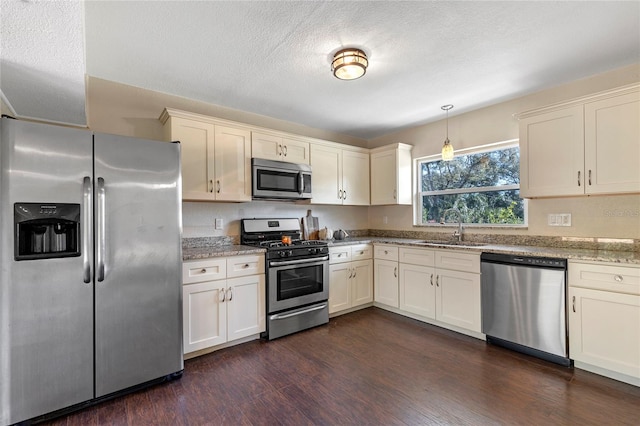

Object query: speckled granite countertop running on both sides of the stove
[182,237,640,265]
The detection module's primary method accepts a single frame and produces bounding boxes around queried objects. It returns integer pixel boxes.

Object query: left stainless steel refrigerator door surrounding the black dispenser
[0,118,93,424]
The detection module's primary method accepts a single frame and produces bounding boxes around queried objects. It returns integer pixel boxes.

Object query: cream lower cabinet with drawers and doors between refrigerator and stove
[182,255,266,354]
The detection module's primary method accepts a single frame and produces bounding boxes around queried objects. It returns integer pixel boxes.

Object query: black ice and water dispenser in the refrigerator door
[14,203,80,260]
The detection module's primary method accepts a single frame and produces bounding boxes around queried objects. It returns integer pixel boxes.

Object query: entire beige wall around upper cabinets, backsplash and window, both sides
[86,64,640,238]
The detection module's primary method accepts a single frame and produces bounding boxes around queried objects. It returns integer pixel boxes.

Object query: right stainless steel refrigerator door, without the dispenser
[94,134,183,397]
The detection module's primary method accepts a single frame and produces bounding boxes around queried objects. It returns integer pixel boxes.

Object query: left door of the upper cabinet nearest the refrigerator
[170,117,215,200]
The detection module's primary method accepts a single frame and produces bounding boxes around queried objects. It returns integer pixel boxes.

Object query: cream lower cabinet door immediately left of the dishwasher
[436,269,481,332]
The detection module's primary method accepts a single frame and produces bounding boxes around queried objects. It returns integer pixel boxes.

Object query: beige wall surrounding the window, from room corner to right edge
[369,64,640,238]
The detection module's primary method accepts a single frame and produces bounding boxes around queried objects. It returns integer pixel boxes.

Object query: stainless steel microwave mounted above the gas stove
[251,158,311,200]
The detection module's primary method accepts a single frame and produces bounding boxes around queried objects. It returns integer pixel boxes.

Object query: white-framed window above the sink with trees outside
[416,141,526,226]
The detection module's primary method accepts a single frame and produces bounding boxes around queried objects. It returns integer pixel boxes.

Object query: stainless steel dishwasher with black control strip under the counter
[480,253,571,366]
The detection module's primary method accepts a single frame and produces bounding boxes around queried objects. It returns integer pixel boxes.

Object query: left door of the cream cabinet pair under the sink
[400,263,436,319]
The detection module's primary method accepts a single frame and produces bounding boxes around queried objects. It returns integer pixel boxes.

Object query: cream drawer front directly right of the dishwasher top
[569,262,640,294]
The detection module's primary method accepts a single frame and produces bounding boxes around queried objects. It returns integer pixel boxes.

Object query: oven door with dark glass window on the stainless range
[267,256,329,314]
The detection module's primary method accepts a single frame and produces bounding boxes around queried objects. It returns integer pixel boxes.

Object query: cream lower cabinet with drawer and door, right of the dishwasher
[569,261,640,386]
